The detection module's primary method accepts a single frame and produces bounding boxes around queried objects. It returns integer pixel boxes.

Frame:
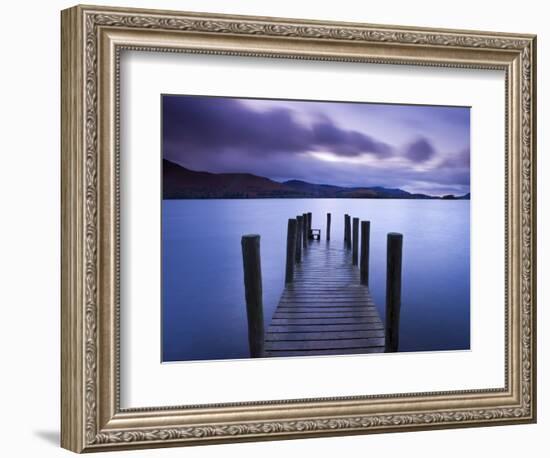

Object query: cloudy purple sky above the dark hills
[162,95,470,195]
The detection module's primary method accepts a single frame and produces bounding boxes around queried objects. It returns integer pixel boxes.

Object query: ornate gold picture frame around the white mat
[61,6,536,452]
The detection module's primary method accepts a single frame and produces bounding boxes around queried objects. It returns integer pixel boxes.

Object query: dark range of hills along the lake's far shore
[162,159,470,199]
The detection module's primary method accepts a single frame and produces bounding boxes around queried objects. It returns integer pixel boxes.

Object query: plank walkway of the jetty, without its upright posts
[264,240,385,357]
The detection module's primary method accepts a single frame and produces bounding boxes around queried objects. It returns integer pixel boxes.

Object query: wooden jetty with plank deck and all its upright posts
[242,213,402,357]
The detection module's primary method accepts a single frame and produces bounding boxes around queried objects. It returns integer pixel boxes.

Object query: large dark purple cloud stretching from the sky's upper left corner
[163,96,392,160]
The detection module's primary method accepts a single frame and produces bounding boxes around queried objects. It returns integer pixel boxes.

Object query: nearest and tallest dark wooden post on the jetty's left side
[241,234,264,358]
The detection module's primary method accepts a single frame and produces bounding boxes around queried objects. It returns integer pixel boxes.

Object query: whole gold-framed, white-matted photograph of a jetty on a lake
[61,6,536,452]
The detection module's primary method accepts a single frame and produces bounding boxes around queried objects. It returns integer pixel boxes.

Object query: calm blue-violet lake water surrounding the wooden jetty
[162,199,470,361]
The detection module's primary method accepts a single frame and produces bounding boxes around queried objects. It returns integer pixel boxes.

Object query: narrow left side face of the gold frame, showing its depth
[60,7,86,453]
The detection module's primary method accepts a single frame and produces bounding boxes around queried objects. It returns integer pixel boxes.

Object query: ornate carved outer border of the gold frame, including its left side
[61,6,536,452]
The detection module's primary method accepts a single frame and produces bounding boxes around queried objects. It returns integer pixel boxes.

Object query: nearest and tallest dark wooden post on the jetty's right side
[386,232,403,352]
